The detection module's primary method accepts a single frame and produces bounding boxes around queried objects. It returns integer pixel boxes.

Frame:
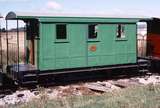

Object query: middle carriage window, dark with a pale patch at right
[88,25,98,39]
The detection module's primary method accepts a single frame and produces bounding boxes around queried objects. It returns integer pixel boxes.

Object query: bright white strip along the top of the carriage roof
[8,12,151,18]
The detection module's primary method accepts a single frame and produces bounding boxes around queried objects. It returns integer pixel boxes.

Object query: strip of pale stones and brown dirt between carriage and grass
[0,75,160,106]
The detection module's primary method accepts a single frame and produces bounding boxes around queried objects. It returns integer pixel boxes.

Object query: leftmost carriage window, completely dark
[56,24,67,39]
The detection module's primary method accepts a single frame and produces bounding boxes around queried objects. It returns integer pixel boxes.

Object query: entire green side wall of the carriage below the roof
[38,23,136,70]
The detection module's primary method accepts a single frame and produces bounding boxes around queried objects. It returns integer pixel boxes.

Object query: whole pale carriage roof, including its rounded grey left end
[6,12,150,20]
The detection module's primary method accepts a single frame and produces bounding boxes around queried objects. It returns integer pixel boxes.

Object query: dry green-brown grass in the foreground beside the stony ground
[7,85,160,108]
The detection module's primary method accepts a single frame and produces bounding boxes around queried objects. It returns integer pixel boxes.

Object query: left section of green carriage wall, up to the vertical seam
[39,23,87,70]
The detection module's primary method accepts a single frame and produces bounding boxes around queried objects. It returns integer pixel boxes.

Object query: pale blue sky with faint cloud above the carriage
[0,0,160,27]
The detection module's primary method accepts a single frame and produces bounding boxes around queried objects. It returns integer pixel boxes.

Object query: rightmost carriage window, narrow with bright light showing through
[117,24,125,38]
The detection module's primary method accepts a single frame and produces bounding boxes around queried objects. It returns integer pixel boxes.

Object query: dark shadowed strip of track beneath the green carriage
[0,70,148,98]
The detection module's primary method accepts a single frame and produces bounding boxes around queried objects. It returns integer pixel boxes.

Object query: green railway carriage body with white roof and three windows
[6,12,149,84]
